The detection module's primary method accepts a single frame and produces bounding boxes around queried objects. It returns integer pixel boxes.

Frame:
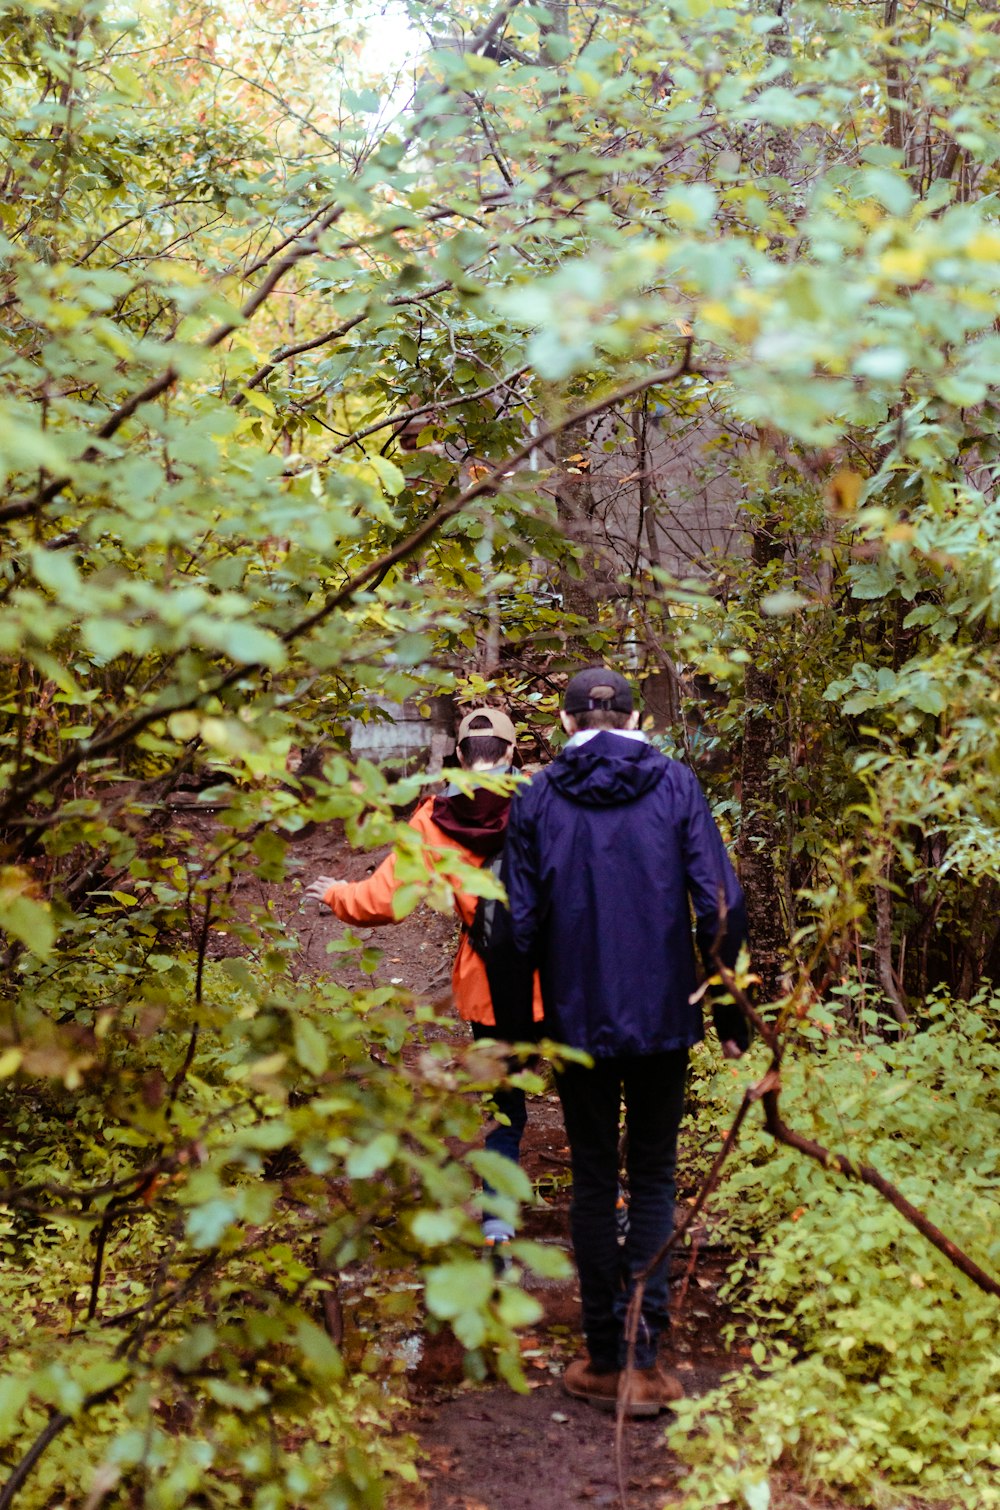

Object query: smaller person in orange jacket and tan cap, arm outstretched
[305,708,542,1246]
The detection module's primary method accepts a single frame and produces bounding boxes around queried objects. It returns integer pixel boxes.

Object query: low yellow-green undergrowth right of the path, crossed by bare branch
[671,991,1000,1510]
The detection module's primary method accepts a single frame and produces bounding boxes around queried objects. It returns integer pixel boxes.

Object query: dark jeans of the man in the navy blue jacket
[556,1048,687,1371]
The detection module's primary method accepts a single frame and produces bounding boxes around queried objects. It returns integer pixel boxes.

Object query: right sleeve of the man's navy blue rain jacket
[683,772,749,1048]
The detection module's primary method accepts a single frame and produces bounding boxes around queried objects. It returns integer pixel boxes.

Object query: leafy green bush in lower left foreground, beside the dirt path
[0,957,555,1510]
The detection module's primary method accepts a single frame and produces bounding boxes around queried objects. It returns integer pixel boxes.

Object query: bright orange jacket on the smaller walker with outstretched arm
[323,797,542,1027]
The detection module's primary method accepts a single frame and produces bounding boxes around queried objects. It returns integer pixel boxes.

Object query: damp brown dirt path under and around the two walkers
[205,814,840,1510]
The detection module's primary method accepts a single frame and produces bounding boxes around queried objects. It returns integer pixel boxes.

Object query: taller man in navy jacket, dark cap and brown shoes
[504,666,748,1415]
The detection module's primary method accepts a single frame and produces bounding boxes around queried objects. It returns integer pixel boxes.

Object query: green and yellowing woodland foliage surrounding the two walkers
[0,0,1000,1510]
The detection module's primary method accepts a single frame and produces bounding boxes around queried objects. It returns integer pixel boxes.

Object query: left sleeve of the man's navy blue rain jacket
[485,793,539,1043]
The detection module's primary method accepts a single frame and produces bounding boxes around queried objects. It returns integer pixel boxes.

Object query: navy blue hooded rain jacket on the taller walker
[494,731,748,1059]
